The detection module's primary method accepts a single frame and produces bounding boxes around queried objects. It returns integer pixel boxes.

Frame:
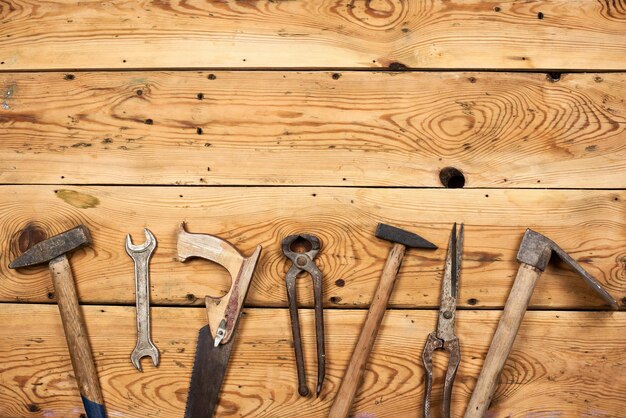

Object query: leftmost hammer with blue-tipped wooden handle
[9,225,106,418]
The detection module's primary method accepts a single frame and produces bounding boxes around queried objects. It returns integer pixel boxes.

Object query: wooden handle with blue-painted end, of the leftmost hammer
[49,255,106,418]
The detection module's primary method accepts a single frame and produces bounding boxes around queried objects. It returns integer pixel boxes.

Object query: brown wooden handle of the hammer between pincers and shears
[328,243,406,418]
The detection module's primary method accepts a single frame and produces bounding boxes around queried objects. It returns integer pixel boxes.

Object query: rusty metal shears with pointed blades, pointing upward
[422,223,463,418]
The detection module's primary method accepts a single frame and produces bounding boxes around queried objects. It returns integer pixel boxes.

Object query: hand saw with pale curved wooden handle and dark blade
[177,223,261,418]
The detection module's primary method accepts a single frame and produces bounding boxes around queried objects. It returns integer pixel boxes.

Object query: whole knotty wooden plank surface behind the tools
[0,0,626,418]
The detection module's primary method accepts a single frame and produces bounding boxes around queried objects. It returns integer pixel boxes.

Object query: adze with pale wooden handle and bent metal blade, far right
[465,229,619,418]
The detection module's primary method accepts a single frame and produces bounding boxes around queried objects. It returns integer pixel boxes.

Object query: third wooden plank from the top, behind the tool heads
[0,186,626,309]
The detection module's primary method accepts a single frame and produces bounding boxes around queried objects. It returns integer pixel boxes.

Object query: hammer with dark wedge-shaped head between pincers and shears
[328,224,437,418]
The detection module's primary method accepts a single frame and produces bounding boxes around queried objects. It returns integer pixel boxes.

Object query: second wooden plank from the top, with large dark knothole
[0,71,626,188]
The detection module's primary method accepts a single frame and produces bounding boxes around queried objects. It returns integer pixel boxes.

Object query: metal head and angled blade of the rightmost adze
[517,229,619,309]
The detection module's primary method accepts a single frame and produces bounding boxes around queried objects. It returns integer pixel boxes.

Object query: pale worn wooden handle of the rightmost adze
[465,263,542,418]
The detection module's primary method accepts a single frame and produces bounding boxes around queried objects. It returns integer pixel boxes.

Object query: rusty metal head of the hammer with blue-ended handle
[9,225,91,269]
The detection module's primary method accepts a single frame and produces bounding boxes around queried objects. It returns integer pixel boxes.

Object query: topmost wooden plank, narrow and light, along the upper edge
[0,0,626,70]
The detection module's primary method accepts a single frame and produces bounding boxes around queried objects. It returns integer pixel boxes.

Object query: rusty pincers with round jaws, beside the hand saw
[282,234,326,396]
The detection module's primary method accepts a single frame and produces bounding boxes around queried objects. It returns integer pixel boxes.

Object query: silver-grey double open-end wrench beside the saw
[126,228,159,371]
